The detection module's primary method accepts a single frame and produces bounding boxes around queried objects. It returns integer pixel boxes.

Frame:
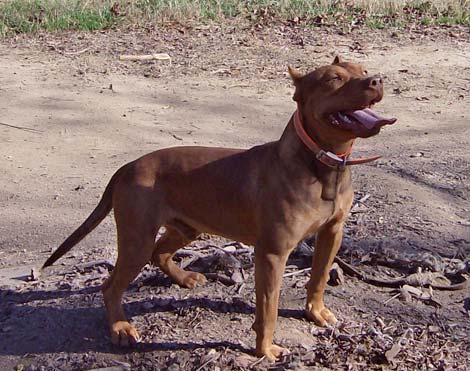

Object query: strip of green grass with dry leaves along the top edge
[0,0,470,37]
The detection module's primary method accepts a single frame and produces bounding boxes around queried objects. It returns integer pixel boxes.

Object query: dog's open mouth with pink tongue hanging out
[330,108,397,133]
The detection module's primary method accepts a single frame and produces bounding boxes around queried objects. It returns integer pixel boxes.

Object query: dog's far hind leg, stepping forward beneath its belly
[152,225,206,289]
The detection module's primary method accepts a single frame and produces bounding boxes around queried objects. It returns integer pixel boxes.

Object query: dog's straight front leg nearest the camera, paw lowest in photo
[253,244,291,361]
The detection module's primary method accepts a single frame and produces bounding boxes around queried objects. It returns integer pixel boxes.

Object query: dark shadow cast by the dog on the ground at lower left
[0,286,304,356]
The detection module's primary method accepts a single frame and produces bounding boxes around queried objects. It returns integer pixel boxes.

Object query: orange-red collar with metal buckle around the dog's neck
[293,109,382,169]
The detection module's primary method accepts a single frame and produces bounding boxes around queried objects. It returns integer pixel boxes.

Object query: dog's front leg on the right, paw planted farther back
[306,222,343,326]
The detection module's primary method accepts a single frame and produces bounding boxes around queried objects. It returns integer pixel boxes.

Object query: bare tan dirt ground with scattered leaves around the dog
[0,24,470,371]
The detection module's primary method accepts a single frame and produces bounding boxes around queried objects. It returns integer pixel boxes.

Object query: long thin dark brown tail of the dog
[41,168,122,269]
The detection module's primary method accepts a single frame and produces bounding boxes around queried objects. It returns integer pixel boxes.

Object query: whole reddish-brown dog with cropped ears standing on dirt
[44,57,395,360]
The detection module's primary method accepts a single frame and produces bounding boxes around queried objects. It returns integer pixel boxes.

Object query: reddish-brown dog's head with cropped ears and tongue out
[289,57,396,140]
